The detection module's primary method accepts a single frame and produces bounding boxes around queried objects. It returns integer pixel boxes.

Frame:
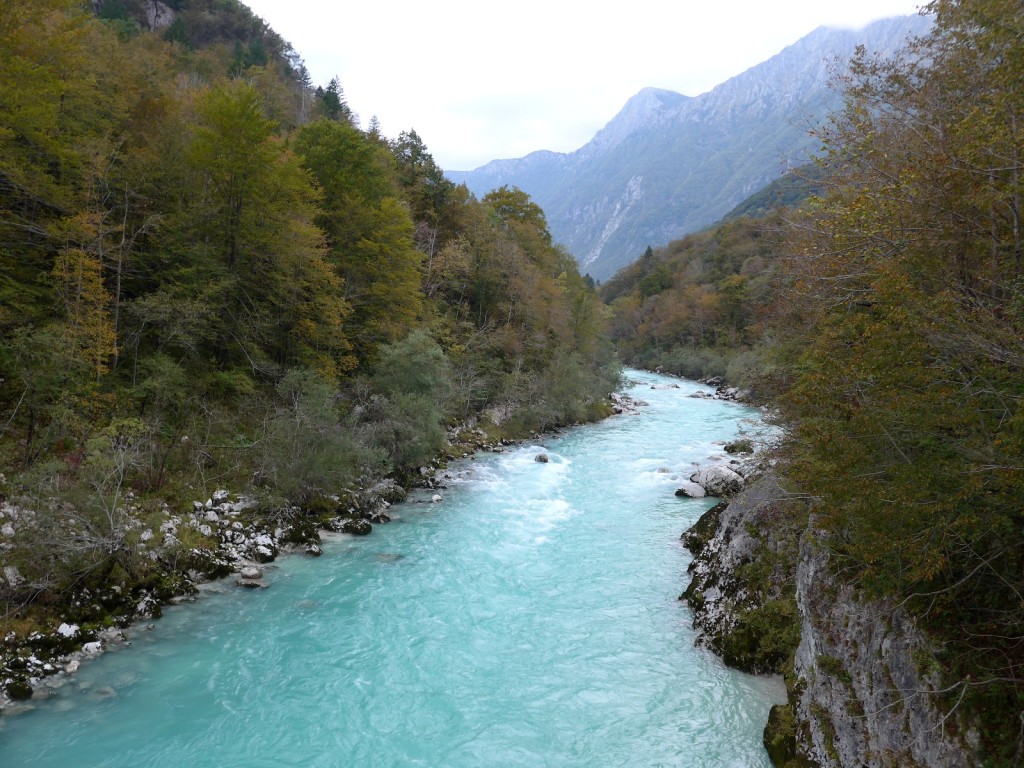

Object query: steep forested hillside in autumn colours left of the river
[0,0,618,663]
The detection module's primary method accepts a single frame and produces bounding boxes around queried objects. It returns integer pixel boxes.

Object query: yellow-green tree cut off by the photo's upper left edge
[0,0,125,332]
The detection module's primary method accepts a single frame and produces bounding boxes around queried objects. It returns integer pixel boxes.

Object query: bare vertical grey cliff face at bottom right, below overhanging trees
[791,532,980,768]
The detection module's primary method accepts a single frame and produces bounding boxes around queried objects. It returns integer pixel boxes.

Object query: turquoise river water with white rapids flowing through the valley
[0,372,784,768]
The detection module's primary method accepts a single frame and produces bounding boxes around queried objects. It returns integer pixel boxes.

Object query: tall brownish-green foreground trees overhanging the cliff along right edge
[777,0,1024,765]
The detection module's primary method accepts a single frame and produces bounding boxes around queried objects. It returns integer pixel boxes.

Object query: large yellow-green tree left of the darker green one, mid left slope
[157,84,351,376]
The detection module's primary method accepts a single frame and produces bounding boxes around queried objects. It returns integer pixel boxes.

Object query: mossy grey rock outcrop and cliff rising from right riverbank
[681,474,981,768]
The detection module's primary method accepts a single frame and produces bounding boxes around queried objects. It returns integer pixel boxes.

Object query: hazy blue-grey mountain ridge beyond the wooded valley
[447,16,929,280]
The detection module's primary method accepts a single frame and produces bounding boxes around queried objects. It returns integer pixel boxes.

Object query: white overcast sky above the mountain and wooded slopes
[243,0,925,170]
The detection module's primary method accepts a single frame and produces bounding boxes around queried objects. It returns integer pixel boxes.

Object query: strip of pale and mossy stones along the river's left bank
[0,393,622,714]
